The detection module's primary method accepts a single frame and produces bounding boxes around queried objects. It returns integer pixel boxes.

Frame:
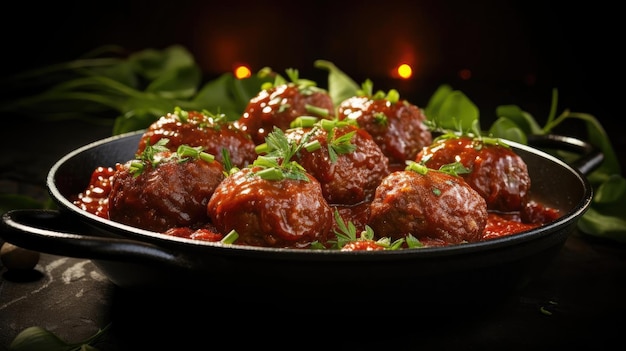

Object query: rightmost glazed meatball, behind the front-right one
[415,135,531,212]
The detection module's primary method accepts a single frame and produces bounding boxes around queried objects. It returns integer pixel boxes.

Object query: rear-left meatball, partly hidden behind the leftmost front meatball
[137,109,257,167]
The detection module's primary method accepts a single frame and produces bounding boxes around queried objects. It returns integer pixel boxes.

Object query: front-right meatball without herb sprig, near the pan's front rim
[368,169,487,246]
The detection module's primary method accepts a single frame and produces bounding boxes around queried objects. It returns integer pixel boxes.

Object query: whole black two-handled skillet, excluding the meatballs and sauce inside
[2,131,603,308]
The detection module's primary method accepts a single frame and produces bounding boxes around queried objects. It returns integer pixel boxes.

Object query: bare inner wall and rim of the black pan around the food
[47,131,591,256]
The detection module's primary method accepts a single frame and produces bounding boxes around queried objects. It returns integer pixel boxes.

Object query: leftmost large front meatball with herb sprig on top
[108,150,225,233]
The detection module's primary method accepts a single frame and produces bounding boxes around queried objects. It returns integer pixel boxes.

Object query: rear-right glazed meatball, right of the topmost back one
[337,96,432,168]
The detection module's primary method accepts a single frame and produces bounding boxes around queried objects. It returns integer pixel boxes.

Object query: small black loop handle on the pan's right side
[528,134,604,175]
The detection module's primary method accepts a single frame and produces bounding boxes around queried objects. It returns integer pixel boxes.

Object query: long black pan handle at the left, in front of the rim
[0,209,193,268]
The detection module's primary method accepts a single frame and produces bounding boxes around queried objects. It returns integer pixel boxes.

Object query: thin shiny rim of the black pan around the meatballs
[47,130,592,258]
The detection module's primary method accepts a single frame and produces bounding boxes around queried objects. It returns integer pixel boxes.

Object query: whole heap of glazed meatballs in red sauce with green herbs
[74,72,560,250]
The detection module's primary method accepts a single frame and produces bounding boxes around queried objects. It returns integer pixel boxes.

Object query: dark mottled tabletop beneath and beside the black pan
[0,119,626,350]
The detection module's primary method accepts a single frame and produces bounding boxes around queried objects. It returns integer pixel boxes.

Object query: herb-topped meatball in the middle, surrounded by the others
[285,125,389,205]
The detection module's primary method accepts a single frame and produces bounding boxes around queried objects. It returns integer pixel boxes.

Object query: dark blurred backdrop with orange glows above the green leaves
[0,0,626,166]
